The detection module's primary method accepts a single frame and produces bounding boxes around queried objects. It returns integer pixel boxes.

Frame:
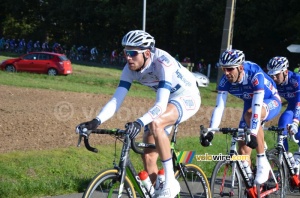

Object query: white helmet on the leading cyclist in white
[122,30,155,49]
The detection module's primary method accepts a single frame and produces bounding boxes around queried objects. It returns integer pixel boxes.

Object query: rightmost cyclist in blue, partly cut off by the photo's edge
[267,56,300,169]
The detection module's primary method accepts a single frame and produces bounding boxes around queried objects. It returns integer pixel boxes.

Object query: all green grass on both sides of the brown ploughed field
[0,53,288,198]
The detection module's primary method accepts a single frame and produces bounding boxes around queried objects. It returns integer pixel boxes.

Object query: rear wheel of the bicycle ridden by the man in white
[175,164,211,198]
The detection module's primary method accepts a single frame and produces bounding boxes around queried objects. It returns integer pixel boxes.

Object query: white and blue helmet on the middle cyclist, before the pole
[219,49,245,67]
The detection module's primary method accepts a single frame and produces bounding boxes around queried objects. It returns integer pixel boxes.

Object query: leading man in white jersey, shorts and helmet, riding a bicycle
[79,30,201,198]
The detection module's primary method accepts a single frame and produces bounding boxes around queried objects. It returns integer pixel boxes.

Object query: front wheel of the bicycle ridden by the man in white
[82,169,136,198]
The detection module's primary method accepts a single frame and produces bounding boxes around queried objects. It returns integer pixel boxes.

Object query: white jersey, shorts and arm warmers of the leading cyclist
[97,48,201,126]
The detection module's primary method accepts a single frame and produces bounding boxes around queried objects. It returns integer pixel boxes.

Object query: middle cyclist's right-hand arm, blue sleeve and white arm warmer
[250,73,265,135]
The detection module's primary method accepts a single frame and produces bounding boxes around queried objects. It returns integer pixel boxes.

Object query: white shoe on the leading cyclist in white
[155,180,180,198]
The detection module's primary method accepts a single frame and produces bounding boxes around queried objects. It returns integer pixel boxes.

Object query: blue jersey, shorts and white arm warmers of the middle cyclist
[210,61,281,135]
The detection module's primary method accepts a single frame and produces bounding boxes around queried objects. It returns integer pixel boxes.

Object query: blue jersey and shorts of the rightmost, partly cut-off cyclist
[277,71,300,148]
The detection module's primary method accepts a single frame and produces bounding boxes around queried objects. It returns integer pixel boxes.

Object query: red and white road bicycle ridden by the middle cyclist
[200,126,285,198]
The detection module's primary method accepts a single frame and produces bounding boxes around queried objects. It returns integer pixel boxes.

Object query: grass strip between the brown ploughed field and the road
[0,132,296,198]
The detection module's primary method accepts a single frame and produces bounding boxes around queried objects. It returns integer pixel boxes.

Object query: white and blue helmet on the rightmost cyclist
[267,56,289,75]
